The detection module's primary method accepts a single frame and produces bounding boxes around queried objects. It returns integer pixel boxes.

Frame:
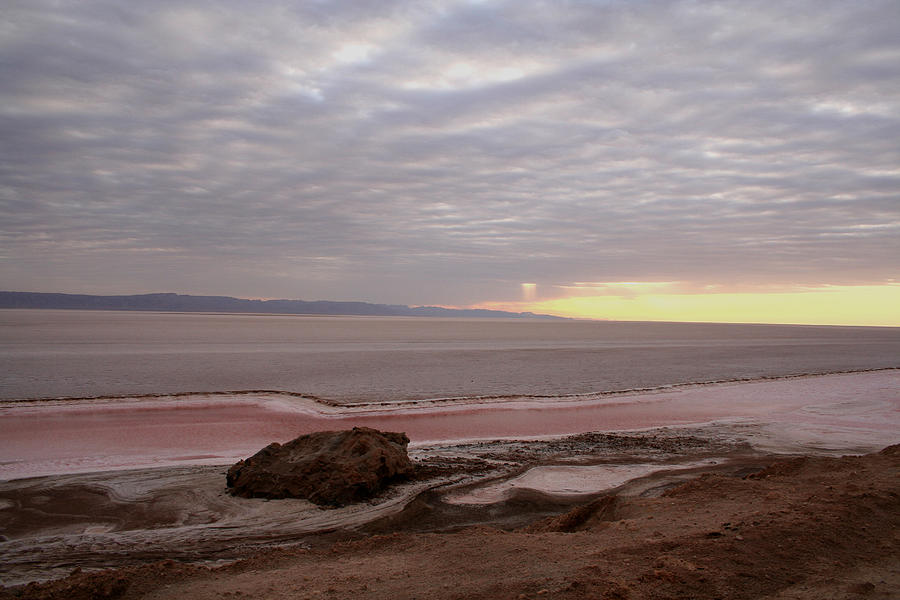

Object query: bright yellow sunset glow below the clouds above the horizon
[479,282,900,327]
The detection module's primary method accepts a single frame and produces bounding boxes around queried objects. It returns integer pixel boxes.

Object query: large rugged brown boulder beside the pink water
[226,427,413,506]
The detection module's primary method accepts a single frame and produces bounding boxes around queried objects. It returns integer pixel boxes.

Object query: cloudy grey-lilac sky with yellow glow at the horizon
[0,0,900,325]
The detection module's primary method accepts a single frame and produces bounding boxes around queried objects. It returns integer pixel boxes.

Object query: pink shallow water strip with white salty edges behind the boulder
[0,369,900,480]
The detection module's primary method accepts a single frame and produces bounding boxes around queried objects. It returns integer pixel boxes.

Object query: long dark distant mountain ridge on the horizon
[0,291,564,319]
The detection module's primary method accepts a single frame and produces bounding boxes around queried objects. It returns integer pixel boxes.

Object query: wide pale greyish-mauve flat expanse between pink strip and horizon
[0,310,900,403]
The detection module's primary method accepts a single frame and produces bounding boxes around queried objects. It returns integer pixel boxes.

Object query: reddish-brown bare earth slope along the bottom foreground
[0,446,900,600]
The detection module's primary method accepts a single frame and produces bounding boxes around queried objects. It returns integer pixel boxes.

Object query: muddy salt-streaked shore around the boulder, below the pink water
[0,429,767,585]
